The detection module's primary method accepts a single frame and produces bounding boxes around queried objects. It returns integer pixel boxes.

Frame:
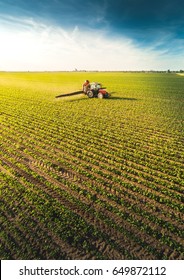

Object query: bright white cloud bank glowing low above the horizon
[0,15,184,71]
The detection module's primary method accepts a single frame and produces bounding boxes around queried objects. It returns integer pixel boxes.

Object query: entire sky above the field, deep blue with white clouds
[0,0,184,71]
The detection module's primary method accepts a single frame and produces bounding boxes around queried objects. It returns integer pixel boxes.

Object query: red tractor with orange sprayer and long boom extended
[56,80,110,98]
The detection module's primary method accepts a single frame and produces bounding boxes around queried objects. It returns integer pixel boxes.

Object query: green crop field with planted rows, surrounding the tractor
[0,72,184,260]
